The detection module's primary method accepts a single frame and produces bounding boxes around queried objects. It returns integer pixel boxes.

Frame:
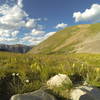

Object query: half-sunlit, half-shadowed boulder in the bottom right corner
[71,86,100,100]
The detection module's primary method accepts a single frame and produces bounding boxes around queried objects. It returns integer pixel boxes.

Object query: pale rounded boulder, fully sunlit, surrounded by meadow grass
[47,74,72,87]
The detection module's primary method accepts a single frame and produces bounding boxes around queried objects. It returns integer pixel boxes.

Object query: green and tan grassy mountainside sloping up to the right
[29,23,100,54]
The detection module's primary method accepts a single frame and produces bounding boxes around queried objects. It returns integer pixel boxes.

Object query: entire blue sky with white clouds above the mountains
[0,0,100,45]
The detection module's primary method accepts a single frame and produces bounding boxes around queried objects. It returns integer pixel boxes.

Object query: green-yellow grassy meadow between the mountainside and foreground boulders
[0,52,100,100]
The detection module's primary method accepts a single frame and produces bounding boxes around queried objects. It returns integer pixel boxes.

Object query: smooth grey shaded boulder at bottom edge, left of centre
[10,89,56,100]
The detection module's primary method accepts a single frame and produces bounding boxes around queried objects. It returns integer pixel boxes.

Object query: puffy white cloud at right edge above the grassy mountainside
[73,4,100,22]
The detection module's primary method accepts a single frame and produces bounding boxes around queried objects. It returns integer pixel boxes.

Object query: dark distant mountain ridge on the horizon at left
[0,44,32,53]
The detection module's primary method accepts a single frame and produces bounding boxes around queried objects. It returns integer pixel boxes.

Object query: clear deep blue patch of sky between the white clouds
[23,0,100,31]
